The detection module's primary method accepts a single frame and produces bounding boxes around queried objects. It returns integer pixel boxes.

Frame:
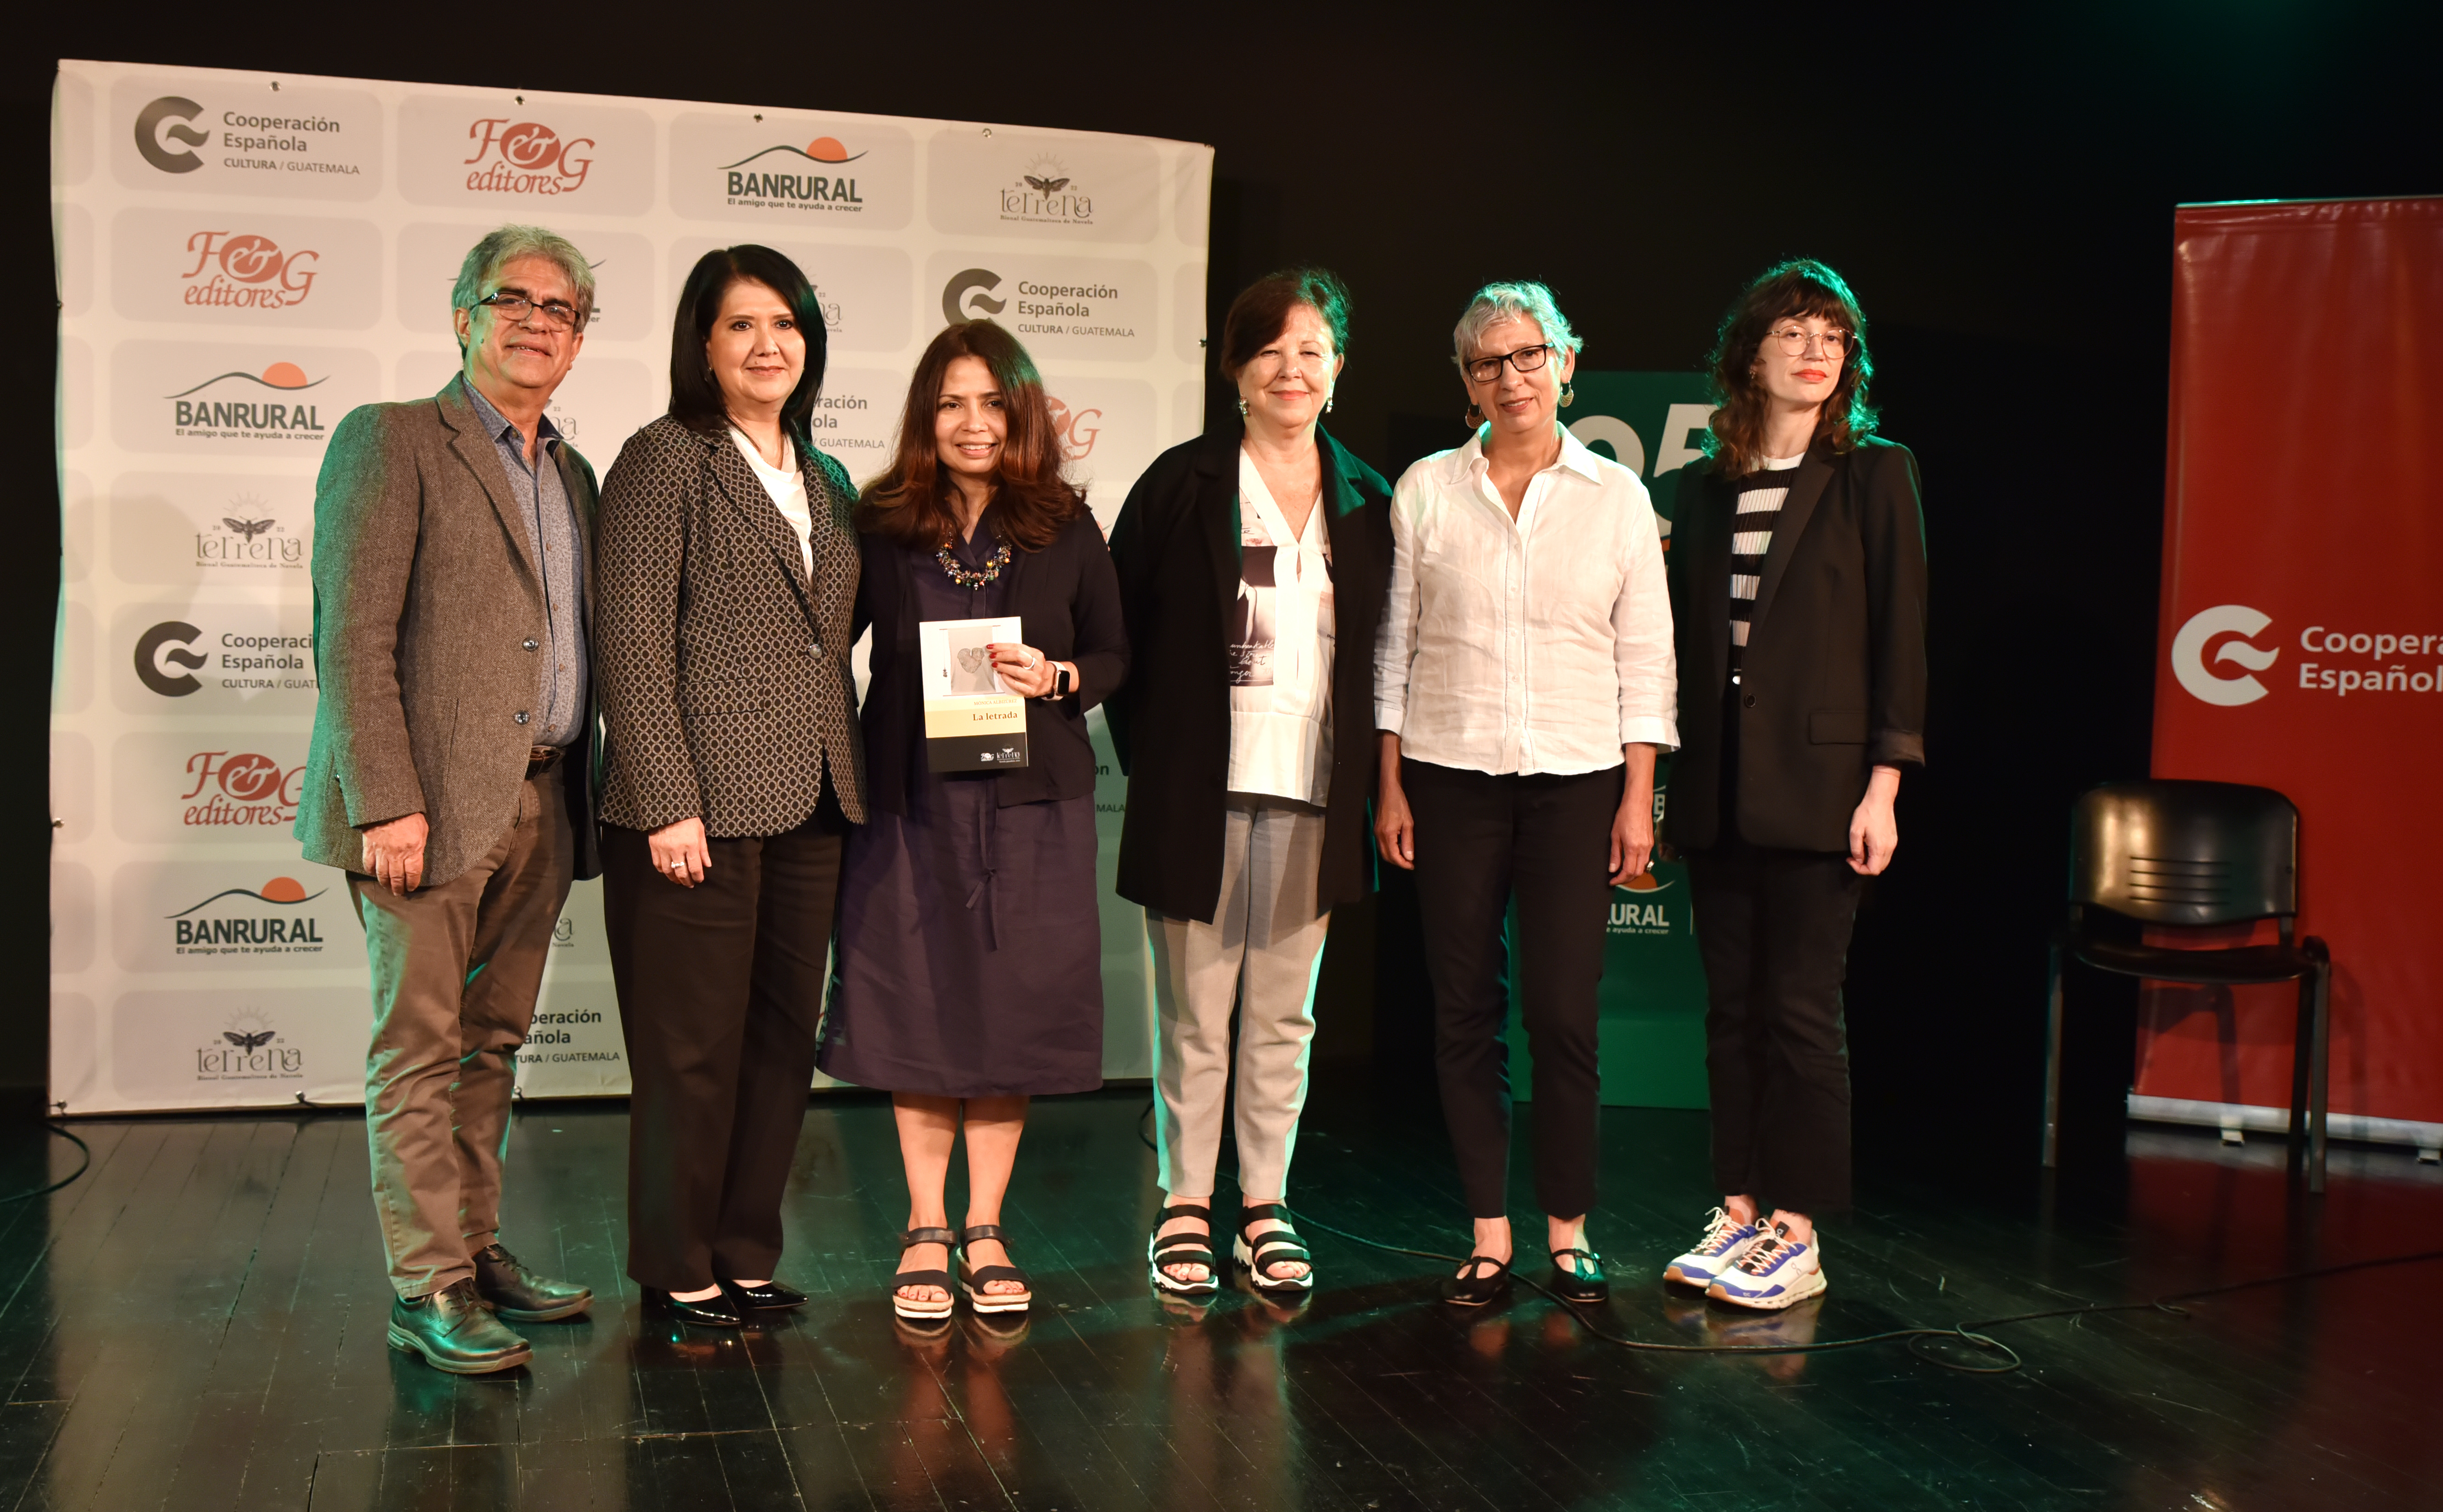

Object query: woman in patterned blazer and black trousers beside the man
[594,247,865,1326]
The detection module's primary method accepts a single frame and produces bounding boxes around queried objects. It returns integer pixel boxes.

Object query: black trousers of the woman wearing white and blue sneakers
[1688,838,1864,1217]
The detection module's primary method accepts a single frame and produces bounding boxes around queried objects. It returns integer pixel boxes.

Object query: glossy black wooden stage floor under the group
[0,1089,2443,1512]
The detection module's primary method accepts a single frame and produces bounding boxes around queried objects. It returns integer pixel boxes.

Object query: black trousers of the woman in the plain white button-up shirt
[1400,759,1627,1219]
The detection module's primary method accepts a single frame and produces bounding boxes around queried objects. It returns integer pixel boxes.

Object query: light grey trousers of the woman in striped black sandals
[1146,794,1332,1202]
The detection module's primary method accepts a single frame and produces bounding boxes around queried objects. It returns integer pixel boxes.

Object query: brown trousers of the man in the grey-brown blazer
[347,765,577,1297]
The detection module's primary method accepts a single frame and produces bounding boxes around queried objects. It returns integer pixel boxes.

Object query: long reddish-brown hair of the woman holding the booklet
[857,320,1085,552]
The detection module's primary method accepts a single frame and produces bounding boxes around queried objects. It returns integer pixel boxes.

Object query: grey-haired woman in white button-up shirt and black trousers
[1375,283,1678,1304]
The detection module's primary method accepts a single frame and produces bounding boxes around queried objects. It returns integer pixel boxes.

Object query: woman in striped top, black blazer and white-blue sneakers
[1664,261,1925,1309]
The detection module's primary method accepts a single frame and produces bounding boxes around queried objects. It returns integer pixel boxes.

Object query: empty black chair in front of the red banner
[2045,782,2333,1192]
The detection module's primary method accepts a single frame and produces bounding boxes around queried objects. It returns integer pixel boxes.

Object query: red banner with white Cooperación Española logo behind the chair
[2130,198,2443,1148]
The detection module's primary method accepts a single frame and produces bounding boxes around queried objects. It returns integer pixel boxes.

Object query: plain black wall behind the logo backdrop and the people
[0,0,2443,1165]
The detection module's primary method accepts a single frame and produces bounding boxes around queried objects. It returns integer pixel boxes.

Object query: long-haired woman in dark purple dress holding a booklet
[819,320,1129,1319]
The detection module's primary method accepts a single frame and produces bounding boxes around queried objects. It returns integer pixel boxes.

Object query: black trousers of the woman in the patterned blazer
[603,791,848,1292]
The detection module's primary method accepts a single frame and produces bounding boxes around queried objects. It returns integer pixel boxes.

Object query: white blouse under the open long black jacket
[1229,452,1334,806]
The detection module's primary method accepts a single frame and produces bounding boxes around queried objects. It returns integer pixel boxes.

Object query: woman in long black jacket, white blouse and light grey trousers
[1107,269,1390,1294]
